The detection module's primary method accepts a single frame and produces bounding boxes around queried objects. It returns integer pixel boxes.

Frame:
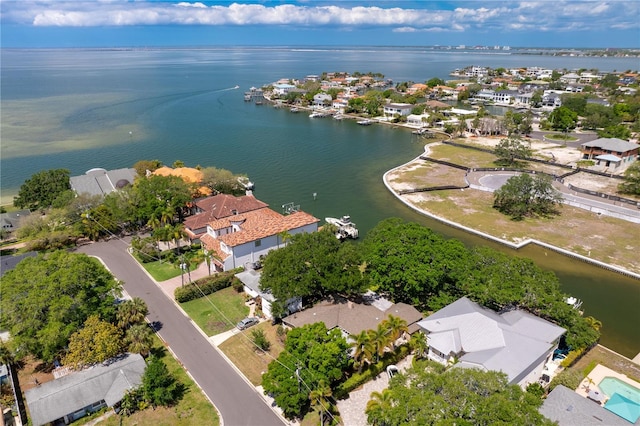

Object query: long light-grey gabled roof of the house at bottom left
[25,354,146,426]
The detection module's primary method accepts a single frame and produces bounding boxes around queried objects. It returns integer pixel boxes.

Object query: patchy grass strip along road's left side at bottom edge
[94,336,220,426]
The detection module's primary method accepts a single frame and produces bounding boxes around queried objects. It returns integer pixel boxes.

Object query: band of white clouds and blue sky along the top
[0,0,640,36]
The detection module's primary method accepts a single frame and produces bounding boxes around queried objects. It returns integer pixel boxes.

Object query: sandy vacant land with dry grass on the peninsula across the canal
[387,138,640,272]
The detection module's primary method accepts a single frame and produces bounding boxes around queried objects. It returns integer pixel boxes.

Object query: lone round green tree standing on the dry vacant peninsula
[493,173,562,220]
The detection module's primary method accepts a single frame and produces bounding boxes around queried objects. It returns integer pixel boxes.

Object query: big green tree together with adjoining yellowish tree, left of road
[0,251,152,368]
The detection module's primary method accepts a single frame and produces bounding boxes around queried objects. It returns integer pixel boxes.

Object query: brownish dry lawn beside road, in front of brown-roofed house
[219,321,284,386]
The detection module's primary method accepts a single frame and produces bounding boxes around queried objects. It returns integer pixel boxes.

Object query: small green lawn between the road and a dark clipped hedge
[181,287,249,336]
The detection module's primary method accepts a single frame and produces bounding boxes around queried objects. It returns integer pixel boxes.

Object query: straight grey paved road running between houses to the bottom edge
[79,240,284,426]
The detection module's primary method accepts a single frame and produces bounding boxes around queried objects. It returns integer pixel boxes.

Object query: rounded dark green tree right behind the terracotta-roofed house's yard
[260,230,367,315]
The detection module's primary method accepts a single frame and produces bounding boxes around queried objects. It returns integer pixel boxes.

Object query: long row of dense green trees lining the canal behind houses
[261,218,599,349]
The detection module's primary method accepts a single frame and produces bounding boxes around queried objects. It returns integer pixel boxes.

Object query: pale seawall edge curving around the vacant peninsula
[382,148,640,281]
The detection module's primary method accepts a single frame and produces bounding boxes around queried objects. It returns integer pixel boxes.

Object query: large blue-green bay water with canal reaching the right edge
[0,48,640,356]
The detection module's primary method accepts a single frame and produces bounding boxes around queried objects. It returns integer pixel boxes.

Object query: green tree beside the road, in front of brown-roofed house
[262,322,351,419]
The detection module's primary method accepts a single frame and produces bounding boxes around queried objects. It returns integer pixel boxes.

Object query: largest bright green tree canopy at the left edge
[0,251,120,361]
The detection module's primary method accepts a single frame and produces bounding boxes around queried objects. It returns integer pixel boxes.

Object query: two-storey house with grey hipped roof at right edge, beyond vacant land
[580,138,640,171]
